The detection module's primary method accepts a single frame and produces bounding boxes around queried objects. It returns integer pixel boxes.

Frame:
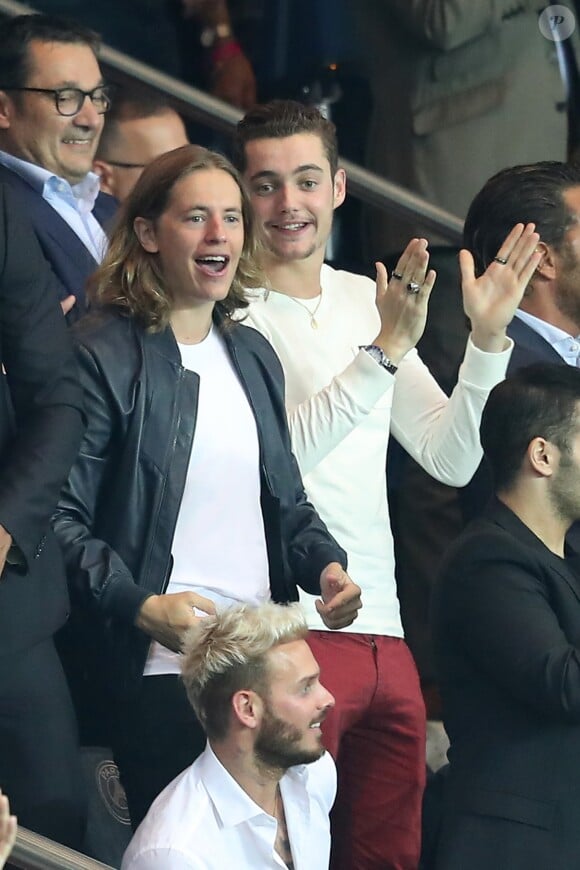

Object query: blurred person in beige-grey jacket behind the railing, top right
[356,0,567,261]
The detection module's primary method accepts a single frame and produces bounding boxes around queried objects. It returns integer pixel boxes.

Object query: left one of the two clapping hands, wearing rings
[373,239,436,364]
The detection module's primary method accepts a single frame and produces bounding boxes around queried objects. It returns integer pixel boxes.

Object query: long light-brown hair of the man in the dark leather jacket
[87,145,264,331]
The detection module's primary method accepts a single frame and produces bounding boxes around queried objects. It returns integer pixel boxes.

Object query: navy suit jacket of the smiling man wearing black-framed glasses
[0,165,117,323]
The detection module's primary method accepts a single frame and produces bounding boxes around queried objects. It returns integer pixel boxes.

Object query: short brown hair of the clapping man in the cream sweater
[233,100,338,178]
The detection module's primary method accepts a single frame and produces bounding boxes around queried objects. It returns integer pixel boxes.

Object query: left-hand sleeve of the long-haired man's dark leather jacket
[53,345,151,624]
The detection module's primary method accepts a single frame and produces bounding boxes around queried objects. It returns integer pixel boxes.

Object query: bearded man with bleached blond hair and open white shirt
[123,603,336,870]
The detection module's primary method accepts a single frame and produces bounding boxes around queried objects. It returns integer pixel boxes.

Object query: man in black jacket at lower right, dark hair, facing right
[433,363,580,870]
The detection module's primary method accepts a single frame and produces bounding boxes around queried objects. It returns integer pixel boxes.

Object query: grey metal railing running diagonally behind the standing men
[0,0,463,244]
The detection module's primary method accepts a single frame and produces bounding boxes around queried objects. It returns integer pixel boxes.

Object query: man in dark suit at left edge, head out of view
[0,185,85,847]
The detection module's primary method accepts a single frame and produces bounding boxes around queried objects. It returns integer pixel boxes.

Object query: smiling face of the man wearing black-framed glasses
[0,40,104,184]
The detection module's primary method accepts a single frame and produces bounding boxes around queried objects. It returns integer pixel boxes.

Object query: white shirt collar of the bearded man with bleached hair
[200,741,306,828]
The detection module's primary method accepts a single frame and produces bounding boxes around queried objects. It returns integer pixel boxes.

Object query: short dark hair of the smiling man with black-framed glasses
[0,15,101,90]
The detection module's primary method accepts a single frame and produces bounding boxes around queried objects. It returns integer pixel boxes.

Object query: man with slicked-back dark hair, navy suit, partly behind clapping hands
[460,161,580,540]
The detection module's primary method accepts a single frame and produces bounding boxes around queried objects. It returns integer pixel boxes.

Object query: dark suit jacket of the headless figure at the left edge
[0,184,83,656]
